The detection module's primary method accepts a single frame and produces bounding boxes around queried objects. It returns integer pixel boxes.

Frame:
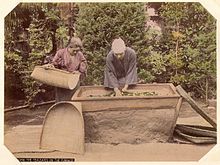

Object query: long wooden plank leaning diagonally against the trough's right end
[176,85,217,129]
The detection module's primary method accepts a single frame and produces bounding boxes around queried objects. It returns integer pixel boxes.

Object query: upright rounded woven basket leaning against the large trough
[40,101,85,154]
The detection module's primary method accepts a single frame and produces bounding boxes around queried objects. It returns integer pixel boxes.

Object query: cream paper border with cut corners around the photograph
[0,0,220,165]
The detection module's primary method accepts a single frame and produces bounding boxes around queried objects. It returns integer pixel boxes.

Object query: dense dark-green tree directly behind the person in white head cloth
[76,3,152,85]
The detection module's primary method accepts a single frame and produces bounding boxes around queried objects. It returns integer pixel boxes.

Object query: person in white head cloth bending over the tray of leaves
[104,38,137,96]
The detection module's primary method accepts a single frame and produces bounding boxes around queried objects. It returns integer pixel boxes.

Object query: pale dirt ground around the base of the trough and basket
[4,99,216,161]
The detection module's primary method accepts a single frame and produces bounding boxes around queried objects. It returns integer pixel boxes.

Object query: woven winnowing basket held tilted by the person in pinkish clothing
[31,66,80,90]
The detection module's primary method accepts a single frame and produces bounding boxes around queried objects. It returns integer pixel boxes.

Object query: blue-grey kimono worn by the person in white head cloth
[104,47,137,88]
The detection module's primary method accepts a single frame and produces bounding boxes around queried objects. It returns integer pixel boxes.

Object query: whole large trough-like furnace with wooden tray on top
[71,83,182,144]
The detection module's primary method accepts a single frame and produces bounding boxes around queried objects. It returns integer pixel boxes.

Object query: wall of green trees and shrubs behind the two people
[4,2,216,103]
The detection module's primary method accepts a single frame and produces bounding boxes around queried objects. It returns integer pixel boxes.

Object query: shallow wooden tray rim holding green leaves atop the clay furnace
[72,83,180,111]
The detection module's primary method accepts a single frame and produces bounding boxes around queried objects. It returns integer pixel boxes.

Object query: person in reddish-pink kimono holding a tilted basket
[45,37,87,102]
